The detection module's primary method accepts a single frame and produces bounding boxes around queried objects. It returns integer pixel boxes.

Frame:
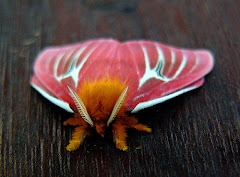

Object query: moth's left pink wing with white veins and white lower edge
[31,39,118,112]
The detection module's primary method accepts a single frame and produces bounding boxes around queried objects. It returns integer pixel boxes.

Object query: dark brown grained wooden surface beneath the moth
[0,0,240,176]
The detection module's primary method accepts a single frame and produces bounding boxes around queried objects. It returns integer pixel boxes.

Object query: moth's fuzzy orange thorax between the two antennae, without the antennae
[77,78,127,122]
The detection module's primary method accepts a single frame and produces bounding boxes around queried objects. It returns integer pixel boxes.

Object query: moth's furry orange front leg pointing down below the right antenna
[112,123,128,151]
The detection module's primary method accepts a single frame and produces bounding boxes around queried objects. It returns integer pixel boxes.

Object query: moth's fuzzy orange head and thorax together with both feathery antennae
[68,80,128,137]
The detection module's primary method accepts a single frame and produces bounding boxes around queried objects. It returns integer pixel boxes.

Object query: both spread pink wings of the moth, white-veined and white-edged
[31,39,213,112]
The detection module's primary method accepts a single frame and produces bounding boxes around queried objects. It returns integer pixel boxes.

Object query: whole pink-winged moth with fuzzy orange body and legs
[31,39,214,151]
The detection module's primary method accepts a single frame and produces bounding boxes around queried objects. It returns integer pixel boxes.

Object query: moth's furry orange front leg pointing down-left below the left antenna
[67,126,88,151]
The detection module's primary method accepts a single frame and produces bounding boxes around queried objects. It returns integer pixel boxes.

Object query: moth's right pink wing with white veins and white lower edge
[118,41,214,112]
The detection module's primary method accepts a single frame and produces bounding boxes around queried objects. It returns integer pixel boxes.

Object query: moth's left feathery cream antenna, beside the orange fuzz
[67,86,93,125]
